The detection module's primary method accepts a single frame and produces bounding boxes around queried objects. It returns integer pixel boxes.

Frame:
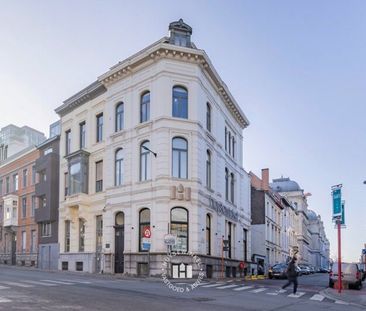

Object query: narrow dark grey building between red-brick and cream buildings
[34,127,60,270]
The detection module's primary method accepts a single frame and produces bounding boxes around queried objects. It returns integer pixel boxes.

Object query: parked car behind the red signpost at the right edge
[329,262,362,290]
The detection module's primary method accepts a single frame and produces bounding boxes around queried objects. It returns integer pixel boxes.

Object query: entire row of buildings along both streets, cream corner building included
[0,20,329,277]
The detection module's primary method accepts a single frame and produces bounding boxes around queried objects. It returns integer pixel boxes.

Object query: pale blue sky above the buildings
[0,0,366,261]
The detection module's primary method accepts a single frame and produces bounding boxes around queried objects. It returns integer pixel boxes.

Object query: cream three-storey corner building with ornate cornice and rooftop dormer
[56,20,251,277]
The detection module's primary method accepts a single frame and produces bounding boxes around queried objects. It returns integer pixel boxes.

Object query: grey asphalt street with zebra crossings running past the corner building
[0,265,364,311]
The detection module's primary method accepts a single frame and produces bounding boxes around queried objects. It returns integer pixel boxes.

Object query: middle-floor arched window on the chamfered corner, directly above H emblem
[172,137,188,179]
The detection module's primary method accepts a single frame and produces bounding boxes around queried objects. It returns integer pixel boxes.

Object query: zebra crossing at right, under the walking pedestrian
[177,281,349,304]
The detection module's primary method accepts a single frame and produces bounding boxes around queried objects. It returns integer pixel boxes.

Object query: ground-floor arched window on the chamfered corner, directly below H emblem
[170,207,188,252]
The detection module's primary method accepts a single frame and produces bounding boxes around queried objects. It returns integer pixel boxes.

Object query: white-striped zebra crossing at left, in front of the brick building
[0,279,91,304]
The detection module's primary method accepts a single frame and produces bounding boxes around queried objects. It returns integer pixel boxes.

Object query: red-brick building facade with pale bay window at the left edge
[0,147,39,266]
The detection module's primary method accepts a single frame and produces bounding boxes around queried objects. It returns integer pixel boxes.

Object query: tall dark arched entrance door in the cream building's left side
[114,212,125,273]
